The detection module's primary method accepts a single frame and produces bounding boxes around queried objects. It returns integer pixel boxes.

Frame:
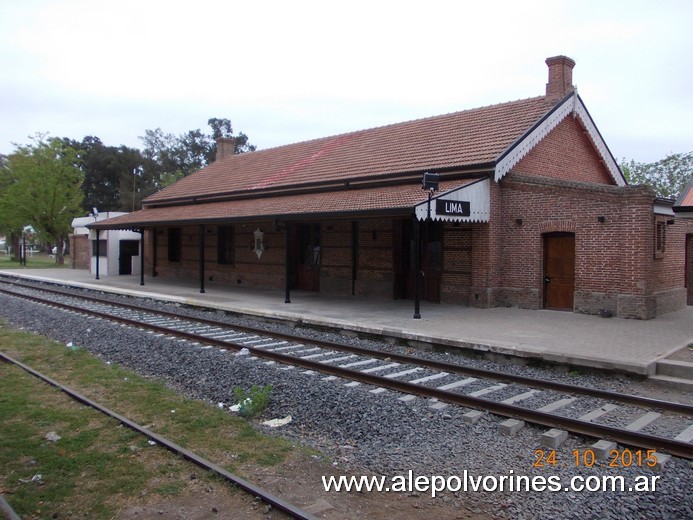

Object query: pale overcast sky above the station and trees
[0,0,693,162]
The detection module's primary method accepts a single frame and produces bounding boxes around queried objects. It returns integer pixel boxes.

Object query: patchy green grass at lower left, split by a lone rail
[0,324,292,519]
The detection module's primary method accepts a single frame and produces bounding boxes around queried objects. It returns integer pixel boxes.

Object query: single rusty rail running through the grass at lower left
[0,351,316,520]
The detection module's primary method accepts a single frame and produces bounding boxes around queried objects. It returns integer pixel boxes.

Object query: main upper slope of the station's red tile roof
[144,96,555,207]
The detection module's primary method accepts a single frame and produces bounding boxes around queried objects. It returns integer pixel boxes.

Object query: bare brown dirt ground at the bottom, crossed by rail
[115,448,493,520]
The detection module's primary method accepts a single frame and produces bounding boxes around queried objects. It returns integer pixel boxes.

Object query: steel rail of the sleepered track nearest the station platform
[0,284,693,416]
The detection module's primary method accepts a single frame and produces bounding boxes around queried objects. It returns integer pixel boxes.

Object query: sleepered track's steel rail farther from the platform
[3,291,693,459]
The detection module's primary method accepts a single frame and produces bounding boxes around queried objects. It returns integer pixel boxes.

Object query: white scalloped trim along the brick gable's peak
[494,92,626,186]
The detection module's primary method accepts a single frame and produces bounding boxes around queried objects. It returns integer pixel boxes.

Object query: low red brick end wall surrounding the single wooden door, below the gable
[496,173,683,319]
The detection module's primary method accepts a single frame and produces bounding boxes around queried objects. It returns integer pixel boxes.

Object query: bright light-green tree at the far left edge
[0,134,84,264]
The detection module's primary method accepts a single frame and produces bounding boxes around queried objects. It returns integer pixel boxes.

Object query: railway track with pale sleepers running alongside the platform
[0,283,693,459]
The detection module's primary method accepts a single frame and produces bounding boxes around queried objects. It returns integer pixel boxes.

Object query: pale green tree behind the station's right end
[621,152,693,199]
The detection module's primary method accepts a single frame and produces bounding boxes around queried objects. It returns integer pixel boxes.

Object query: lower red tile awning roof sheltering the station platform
[90,179,476,229]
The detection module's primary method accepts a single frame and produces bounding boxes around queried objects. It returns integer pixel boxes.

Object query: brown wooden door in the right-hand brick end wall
[544,233,575,310]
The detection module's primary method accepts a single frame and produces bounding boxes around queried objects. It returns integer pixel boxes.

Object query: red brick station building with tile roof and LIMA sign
[90,56,686,319]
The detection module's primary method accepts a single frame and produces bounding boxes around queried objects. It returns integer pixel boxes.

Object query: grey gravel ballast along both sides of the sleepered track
[0,286,693,519]
